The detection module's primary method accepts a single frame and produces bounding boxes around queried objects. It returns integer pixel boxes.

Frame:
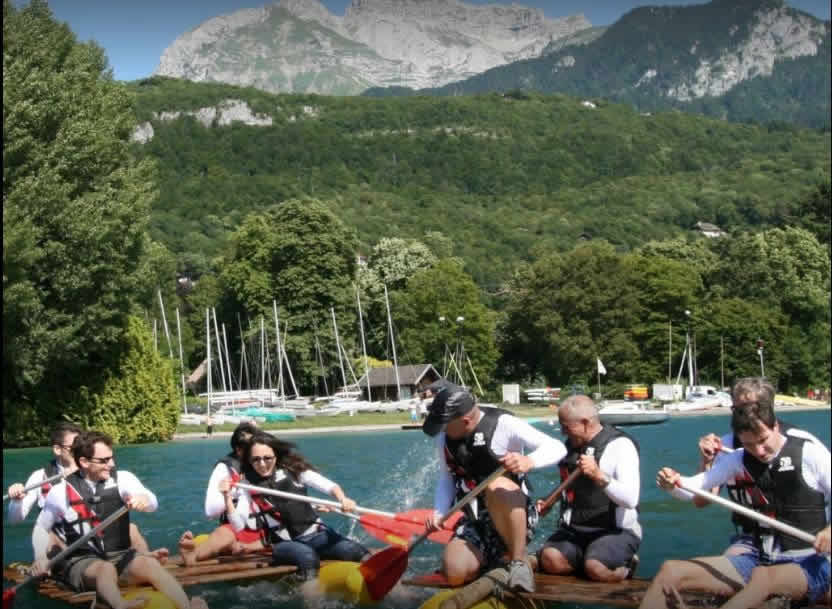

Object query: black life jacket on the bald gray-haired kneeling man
[558,425,640,531]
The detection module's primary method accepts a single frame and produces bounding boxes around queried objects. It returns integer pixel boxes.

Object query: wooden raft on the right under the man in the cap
[402,573,808,609]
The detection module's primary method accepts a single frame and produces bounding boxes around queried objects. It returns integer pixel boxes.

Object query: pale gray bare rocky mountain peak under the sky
[155,0,591,95]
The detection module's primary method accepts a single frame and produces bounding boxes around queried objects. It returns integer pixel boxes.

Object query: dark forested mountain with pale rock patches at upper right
[402,0,831,126]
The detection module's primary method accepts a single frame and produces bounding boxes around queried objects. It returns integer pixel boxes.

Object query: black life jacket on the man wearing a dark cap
[445,408,528,519]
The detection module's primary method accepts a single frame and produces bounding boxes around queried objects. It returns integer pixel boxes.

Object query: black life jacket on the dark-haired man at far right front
[742,435,828,550]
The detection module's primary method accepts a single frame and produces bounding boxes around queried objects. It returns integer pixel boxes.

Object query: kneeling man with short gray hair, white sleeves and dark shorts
[538,395,641,582]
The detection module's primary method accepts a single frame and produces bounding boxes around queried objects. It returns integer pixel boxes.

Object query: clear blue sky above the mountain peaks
[35,0,830,80]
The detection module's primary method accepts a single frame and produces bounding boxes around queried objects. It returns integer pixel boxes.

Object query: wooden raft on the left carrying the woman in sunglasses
[3,554,296,605]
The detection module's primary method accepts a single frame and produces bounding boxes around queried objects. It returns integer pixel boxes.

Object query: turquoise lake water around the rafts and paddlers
[3,410,830,609]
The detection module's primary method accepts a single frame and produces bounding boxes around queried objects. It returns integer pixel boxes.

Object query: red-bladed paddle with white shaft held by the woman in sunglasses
[236,482,453,545]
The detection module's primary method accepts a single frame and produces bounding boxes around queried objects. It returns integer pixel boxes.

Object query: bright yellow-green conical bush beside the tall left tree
[86,317,180,444]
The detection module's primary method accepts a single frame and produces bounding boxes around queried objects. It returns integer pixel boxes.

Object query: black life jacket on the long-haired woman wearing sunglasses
[251,470,318,544]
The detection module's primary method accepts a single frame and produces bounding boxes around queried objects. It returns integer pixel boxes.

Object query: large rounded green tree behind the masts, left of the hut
[220,199,357,389]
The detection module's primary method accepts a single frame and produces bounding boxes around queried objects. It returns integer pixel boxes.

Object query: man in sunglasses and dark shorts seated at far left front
[32,431,205,609]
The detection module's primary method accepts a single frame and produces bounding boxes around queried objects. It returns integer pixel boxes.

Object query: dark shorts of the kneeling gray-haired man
[540,526,641,573]
